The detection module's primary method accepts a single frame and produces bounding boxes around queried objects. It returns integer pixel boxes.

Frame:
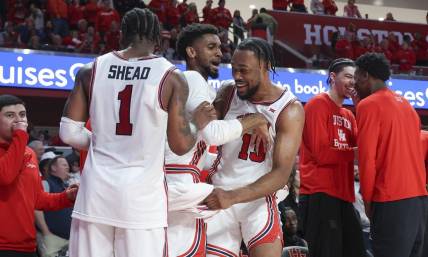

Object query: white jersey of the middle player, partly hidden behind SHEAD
[165,71,216,184]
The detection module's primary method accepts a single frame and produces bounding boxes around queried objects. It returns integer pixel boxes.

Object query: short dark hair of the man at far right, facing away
[355,53,391,81]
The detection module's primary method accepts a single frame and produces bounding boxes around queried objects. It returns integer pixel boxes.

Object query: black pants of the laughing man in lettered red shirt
[299,193,366,257]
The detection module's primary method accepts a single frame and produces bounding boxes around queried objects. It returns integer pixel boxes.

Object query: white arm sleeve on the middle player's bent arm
[199,119,242,145]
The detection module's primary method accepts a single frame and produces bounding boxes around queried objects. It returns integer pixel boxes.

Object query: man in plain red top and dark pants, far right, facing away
[355,53,428,257]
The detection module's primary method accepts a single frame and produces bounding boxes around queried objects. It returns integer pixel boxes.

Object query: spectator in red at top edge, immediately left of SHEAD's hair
[95,0,120,37]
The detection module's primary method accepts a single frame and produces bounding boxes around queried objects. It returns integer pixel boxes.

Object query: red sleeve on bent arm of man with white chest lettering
[303,97,354,166]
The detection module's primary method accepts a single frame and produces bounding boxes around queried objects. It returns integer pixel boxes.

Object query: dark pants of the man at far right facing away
[371,196,428,257]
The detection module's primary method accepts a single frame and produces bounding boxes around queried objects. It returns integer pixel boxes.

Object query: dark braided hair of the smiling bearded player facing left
[236,37,276,73]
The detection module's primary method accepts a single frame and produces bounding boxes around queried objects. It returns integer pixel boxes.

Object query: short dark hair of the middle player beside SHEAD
[176,23,218,59]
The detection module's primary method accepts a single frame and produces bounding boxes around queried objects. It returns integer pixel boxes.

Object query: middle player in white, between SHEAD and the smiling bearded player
[165,23,267,257]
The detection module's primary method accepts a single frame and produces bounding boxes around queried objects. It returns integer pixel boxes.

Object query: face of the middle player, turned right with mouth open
[193,34,222,79]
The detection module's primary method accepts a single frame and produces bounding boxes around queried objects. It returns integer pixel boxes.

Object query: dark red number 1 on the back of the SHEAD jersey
[116,85,132,136]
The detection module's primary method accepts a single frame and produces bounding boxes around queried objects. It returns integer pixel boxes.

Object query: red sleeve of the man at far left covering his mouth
[0,130,28,186]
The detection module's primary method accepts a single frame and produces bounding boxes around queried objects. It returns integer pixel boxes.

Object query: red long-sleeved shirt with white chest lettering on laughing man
[299,93,357,202]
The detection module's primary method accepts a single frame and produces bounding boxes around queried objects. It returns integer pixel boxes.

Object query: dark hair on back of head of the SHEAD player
[120,8,160,46]
